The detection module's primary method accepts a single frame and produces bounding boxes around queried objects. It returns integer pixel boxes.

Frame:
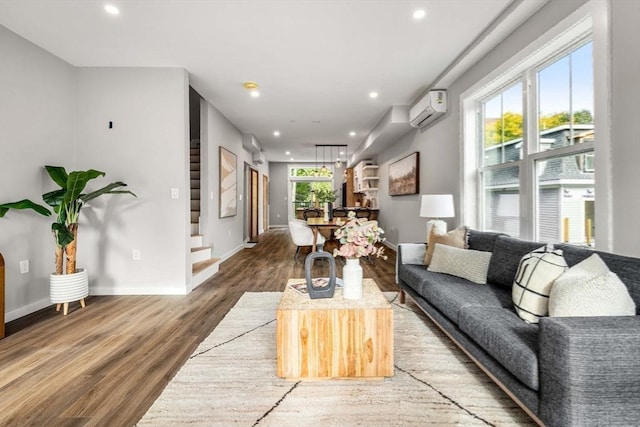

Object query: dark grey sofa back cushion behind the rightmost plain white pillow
[555,244,640,314]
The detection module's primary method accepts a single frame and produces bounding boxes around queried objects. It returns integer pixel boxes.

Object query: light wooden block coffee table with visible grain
[276,279,393,379]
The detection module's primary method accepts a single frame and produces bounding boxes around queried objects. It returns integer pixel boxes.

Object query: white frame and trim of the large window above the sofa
[460,2,611,246]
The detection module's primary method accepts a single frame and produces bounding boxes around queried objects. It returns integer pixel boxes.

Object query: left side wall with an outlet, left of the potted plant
[0,26,75,321]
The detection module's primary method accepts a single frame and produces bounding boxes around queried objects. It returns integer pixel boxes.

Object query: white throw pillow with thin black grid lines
[511,246,568,323]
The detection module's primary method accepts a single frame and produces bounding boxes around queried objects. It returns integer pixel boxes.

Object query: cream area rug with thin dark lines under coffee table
[138,292,534,427]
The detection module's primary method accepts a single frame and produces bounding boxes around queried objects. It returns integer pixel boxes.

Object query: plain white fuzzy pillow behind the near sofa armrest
[549,254,636,317]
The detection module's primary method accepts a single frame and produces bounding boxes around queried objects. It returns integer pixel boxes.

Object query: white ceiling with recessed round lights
[0,0,539,161]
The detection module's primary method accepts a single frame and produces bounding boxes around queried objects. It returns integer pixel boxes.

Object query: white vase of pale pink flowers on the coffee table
[333,211,387,299]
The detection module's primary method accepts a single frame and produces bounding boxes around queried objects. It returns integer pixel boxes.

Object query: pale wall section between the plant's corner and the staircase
[74,67,191,295]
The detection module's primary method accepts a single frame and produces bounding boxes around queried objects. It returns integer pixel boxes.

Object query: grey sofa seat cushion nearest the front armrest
[458,307,539,390]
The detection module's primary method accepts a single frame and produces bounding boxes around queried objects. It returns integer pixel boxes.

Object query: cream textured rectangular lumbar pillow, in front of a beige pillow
[428,243,491,285]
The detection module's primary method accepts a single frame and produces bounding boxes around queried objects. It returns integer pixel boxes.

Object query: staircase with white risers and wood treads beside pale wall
[189,139,220,289]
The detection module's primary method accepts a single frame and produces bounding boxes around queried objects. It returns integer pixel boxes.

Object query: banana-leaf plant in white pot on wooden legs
[0,166,136,315]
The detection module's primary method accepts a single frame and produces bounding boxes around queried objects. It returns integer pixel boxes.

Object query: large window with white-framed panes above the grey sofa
[463,31,597,246]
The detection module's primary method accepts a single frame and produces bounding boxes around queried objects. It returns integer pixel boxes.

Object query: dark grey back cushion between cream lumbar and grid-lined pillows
[487,236,540,290]
